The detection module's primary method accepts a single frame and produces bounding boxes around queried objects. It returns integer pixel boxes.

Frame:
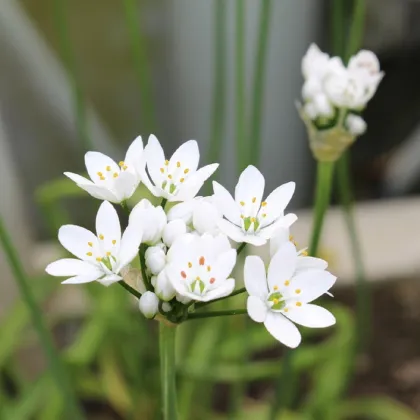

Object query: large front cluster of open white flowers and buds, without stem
[46,135,336,347]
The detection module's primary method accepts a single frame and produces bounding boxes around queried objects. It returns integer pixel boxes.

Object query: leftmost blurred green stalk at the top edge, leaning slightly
[54,0,92,151]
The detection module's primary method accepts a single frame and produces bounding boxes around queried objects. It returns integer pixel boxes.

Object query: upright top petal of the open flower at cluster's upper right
[235,165,265,210]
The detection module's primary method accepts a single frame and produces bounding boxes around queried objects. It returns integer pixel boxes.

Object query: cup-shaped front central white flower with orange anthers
[165,234,236,302]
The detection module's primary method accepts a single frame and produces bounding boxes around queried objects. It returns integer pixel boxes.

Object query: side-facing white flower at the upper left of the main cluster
[64,137,144,203]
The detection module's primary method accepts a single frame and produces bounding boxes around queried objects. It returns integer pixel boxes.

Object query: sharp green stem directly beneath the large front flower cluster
[159,322,178,420]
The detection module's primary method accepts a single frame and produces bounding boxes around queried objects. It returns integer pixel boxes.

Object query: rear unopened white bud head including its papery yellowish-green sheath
[299,44,384,161]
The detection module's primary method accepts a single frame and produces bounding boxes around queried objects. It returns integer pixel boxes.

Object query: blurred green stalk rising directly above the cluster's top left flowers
[124,0,157,132]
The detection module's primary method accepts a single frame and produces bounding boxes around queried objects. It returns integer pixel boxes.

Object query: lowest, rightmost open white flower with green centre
[244,243,336,348]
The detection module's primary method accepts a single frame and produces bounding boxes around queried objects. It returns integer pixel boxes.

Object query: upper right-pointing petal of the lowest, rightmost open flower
[290,270,337,303]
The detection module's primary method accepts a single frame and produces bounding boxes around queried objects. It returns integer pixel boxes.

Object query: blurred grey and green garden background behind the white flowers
[0,0,420,420]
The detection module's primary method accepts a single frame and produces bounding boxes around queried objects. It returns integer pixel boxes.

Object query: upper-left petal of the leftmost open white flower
[58,225,97,260]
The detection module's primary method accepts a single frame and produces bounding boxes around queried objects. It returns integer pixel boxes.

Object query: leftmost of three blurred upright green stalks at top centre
[207,0,227,169]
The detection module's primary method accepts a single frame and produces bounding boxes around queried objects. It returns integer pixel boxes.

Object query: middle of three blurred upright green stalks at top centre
[235,0,248,173]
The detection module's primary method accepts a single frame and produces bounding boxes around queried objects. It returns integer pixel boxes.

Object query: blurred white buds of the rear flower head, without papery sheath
[302,44,384,136]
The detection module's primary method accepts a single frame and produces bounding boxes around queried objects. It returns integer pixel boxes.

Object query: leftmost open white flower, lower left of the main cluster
[46,201,142,285]
